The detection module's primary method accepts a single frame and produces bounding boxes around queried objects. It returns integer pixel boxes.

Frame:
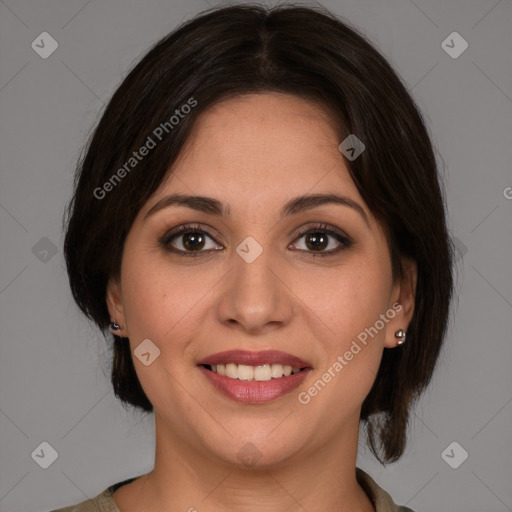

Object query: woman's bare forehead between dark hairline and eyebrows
[160,93,358,195]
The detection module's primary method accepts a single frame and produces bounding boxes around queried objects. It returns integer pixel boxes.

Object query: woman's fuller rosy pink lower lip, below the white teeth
[199,366,311,404]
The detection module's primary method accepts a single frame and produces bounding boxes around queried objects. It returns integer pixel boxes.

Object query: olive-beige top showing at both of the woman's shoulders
[50,468,414,512]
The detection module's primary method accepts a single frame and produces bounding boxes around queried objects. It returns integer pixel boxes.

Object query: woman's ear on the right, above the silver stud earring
[385,258,418,348]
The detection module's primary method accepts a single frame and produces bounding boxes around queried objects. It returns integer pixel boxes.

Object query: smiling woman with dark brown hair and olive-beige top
[53,5,452,512]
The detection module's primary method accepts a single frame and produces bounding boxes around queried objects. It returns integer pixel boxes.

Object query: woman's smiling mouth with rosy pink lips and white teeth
[197,350,313,403]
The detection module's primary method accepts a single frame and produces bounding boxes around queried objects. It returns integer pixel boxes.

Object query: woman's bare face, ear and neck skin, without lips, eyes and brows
[107,93,416,512]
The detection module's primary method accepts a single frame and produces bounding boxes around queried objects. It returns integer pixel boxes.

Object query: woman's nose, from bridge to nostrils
[217,244,296,334]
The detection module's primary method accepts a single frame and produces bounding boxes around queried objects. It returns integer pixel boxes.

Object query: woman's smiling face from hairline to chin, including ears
[107,93,415,464]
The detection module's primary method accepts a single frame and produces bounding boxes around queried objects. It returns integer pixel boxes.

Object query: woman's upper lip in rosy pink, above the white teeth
[197,350,311,368]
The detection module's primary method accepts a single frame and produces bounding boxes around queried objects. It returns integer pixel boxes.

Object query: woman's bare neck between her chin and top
[121,413,374,512]
